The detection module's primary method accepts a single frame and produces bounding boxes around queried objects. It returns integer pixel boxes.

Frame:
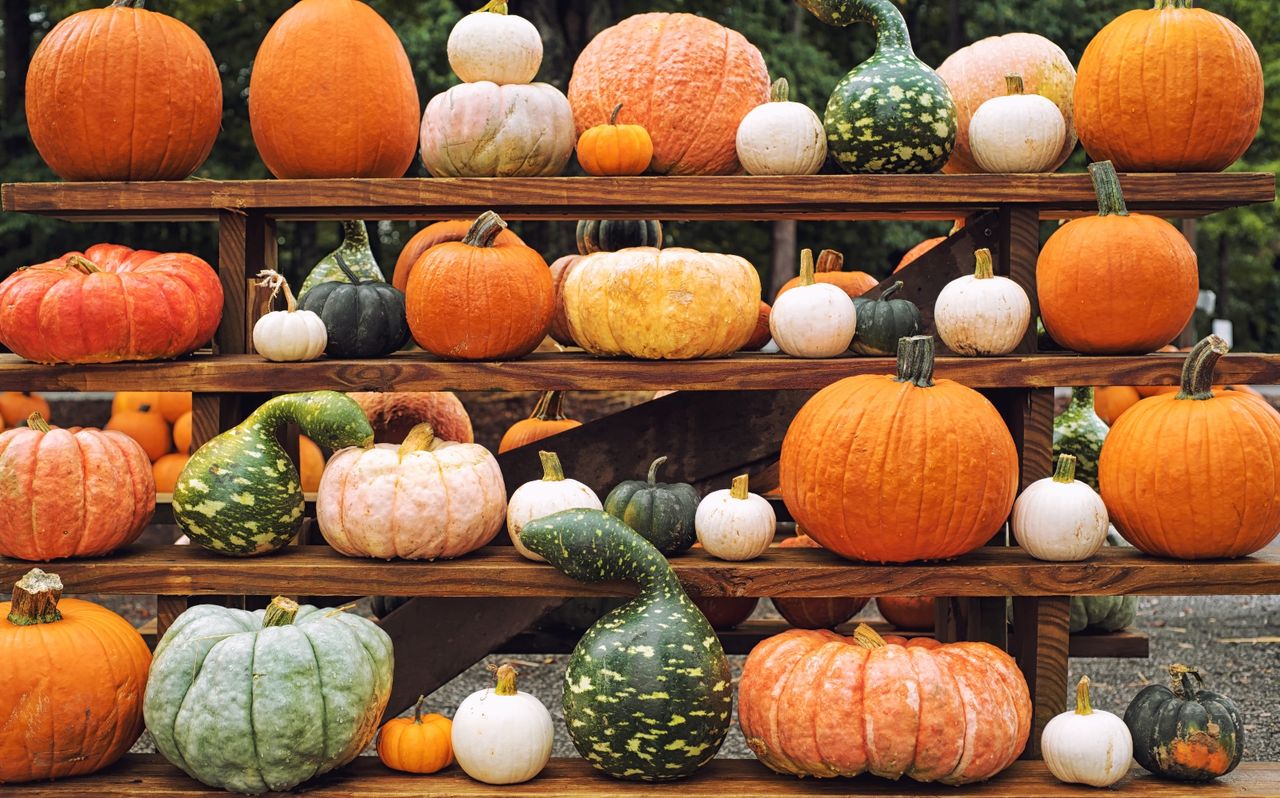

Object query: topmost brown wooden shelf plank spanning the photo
[3,172,1275,222]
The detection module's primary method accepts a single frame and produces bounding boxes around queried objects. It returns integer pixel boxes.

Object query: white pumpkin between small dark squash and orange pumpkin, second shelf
[933,248,1032,355]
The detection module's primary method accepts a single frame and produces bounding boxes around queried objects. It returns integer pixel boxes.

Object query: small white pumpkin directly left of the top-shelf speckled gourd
[737,78,827,174]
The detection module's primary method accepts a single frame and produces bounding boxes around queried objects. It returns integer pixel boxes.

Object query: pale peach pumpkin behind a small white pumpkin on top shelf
[938,32,1075,173]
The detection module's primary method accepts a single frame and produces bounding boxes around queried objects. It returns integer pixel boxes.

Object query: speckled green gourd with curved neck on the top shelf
[796,0,957,173]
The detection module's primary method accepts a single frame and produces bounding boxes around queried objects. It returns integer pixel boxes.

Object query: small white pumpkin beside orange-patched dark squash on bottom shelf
[1041,676,1133,786]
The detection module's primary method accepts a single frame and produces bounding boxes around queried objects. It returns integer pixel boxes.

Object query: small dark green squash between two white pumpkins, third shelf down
[604,457,701,555]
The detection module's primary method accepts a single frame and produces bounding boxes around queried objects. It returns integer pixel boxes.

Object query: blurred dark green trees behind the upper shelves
[0,0,1280,351]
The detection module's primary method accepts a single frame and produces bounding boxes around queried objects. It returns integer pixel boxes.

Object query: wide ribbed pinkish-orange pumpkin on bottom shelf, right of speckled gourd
[737,624,1032,784]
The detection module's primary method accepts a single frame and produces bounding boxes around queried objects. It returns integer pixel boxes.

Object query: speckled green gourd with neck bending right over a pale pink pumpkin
[173,391,374,556]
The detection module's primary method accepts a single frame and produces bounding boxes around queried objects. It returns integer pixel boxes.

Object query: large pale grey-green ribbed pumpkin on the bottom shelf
[142,598,393,794]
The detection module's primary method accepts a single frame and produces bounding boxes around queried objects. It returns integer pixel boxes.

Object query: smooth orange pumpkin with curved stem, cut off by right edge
[1098,336,1280,560]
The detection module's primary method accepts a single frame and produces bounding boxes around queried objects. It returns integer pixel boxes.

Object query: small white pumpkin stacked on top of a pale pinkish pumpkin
[447,0,543,85]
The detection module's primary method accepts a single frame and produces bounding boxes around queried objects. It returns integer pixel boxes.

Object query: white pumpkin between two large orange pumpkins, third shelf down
[1012,455,1108,562]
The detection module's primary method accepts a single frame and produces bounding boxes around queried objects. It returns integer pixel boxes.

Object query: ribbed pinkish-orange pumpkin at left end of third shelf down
[0,415,152,558]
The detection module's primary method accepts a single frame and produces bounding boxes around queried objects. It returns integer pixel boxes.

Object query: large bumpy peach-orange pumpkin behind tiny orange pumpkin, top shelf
[568,13,769,174]
